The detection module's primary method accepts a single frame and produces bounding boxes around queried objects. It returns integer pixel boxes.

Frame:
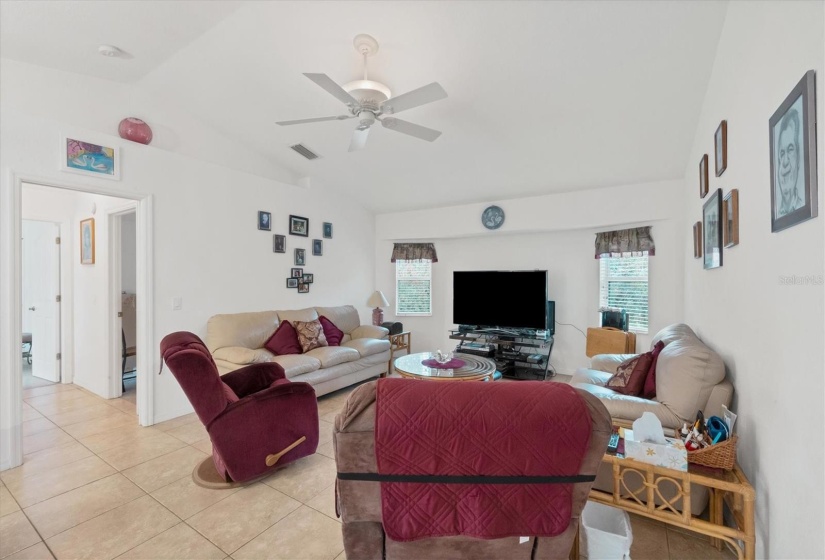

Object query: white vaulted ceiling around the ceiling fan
[0,1,726,212]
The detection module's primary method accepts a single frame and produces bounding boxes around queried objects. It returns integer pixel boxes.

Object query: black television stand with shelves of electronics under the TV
[450,329,555,381]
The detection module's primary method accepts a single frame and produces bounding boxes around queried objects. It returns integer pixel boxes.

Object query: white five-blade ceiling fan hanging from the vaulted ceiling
[276,34,447,152]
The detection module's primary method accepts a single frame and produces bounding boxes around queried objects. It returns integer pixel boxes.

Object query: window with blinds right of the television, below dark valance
[599,257,648,333]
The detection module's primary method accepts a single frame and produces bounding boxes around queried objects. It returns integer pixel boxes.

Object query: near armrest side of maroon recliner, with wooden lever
[206,381,318,481]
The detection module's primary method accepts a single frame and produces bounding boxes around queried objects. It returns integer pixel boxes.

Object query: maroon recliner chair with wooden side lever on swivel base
[160,331,318,482]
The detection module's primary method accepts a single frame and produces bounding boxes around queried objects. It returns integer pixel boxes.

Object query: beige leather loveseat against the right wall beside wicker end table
[570,324,733,429]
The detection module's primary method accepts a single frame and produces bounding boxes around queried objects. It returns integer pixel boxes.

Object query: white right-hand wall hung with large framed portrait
[683,2,825,558]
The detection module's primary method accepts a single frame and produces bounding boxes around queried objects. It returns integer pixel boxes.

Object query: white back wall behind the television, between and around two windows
[375,181,684,374]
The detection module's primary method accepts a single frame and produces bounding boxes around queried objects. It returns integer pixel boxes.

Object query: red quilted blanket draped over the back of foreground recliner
[375,379,591,541]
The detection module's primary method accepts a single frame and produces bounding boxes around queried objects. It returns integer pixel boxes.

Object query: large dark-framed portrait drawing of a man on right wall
[770,70,817,232]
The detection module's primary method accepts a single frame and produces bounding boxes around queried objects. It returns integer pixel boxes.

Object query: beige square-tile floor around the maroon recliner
[0,376,730,560]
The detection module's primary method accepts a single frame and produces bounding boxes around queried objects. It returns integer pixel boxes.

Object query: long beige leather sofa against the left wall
[206,305,390,396]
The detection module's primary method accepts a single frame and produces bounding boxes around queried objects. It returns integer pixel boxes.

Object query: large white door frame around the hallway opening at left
[0,169,155,470]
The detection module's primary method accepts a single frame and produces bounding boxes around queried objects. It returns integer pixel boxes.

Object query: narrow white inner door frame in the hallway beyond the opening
[106,202,137,398]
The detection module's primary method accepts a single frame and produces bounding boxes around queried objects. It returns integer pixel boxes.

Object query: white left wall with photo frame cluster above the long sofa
[0,61,374,446]
